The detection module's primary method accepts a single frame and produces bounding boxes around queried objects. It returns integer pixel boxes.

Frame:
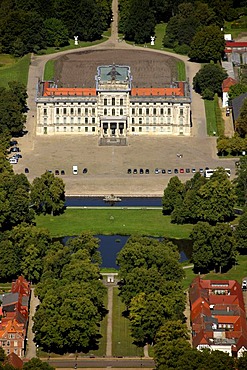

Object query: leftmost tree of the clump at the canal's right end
[162,176,184,215]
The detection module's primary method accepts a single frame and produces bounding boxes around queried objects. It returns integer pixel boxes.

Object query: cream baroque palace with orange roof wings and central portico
[36,65,191,144]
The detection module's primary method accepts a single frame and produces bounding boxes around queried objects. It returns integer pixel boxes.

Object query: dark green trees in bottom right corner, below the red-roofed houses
[154,321,247,370]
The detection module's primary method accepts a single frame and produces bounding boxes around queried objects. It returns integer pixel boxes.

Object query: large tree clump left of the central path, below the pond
[33,234,107,353]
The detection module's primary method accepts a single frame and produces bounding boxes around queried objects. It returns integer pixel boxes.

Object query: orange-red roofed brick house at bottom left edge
[0,276,31,357]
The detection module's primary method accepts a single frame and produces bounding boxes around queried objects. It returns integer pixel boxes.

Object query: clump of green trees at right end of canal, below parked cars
[162,168,236,225]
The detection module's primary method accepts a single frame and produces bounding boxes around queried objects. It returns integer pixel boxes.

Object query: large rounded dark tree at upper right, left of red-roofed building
[189,25,225,63]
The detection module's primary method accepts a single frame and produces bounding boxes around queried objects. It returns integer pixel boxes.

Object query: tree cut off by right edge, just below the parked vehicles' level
[234,156,247,206]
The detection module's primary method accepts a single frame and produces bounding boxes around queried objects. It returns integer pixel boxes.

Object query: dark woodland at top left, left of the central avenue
[0,0,112,56]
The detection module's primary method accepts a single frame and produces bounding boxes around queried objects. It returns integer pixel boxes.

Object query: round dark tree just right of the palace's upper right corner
[193,63,227,95]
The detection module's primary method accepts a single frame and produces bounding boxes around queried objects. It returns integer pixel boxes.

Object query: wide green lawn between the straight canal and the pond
[36,208,193,239]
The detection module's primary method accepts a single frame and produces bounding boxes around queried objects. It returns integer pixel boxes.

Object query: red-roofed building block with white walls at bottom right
[189,277,247,357]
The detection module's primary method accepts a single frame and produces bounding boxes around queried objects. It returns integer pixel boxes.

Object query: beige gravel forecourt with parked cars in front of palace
[14,135,235,196]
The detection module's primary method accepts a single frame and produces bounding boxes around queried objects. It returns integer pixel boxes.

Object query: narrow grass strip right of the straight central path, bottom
[112,288,143,357]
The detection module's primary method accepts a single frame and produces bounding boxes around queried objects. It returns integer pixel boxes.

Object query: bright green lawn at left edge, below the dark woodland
[0,54,30,87]
